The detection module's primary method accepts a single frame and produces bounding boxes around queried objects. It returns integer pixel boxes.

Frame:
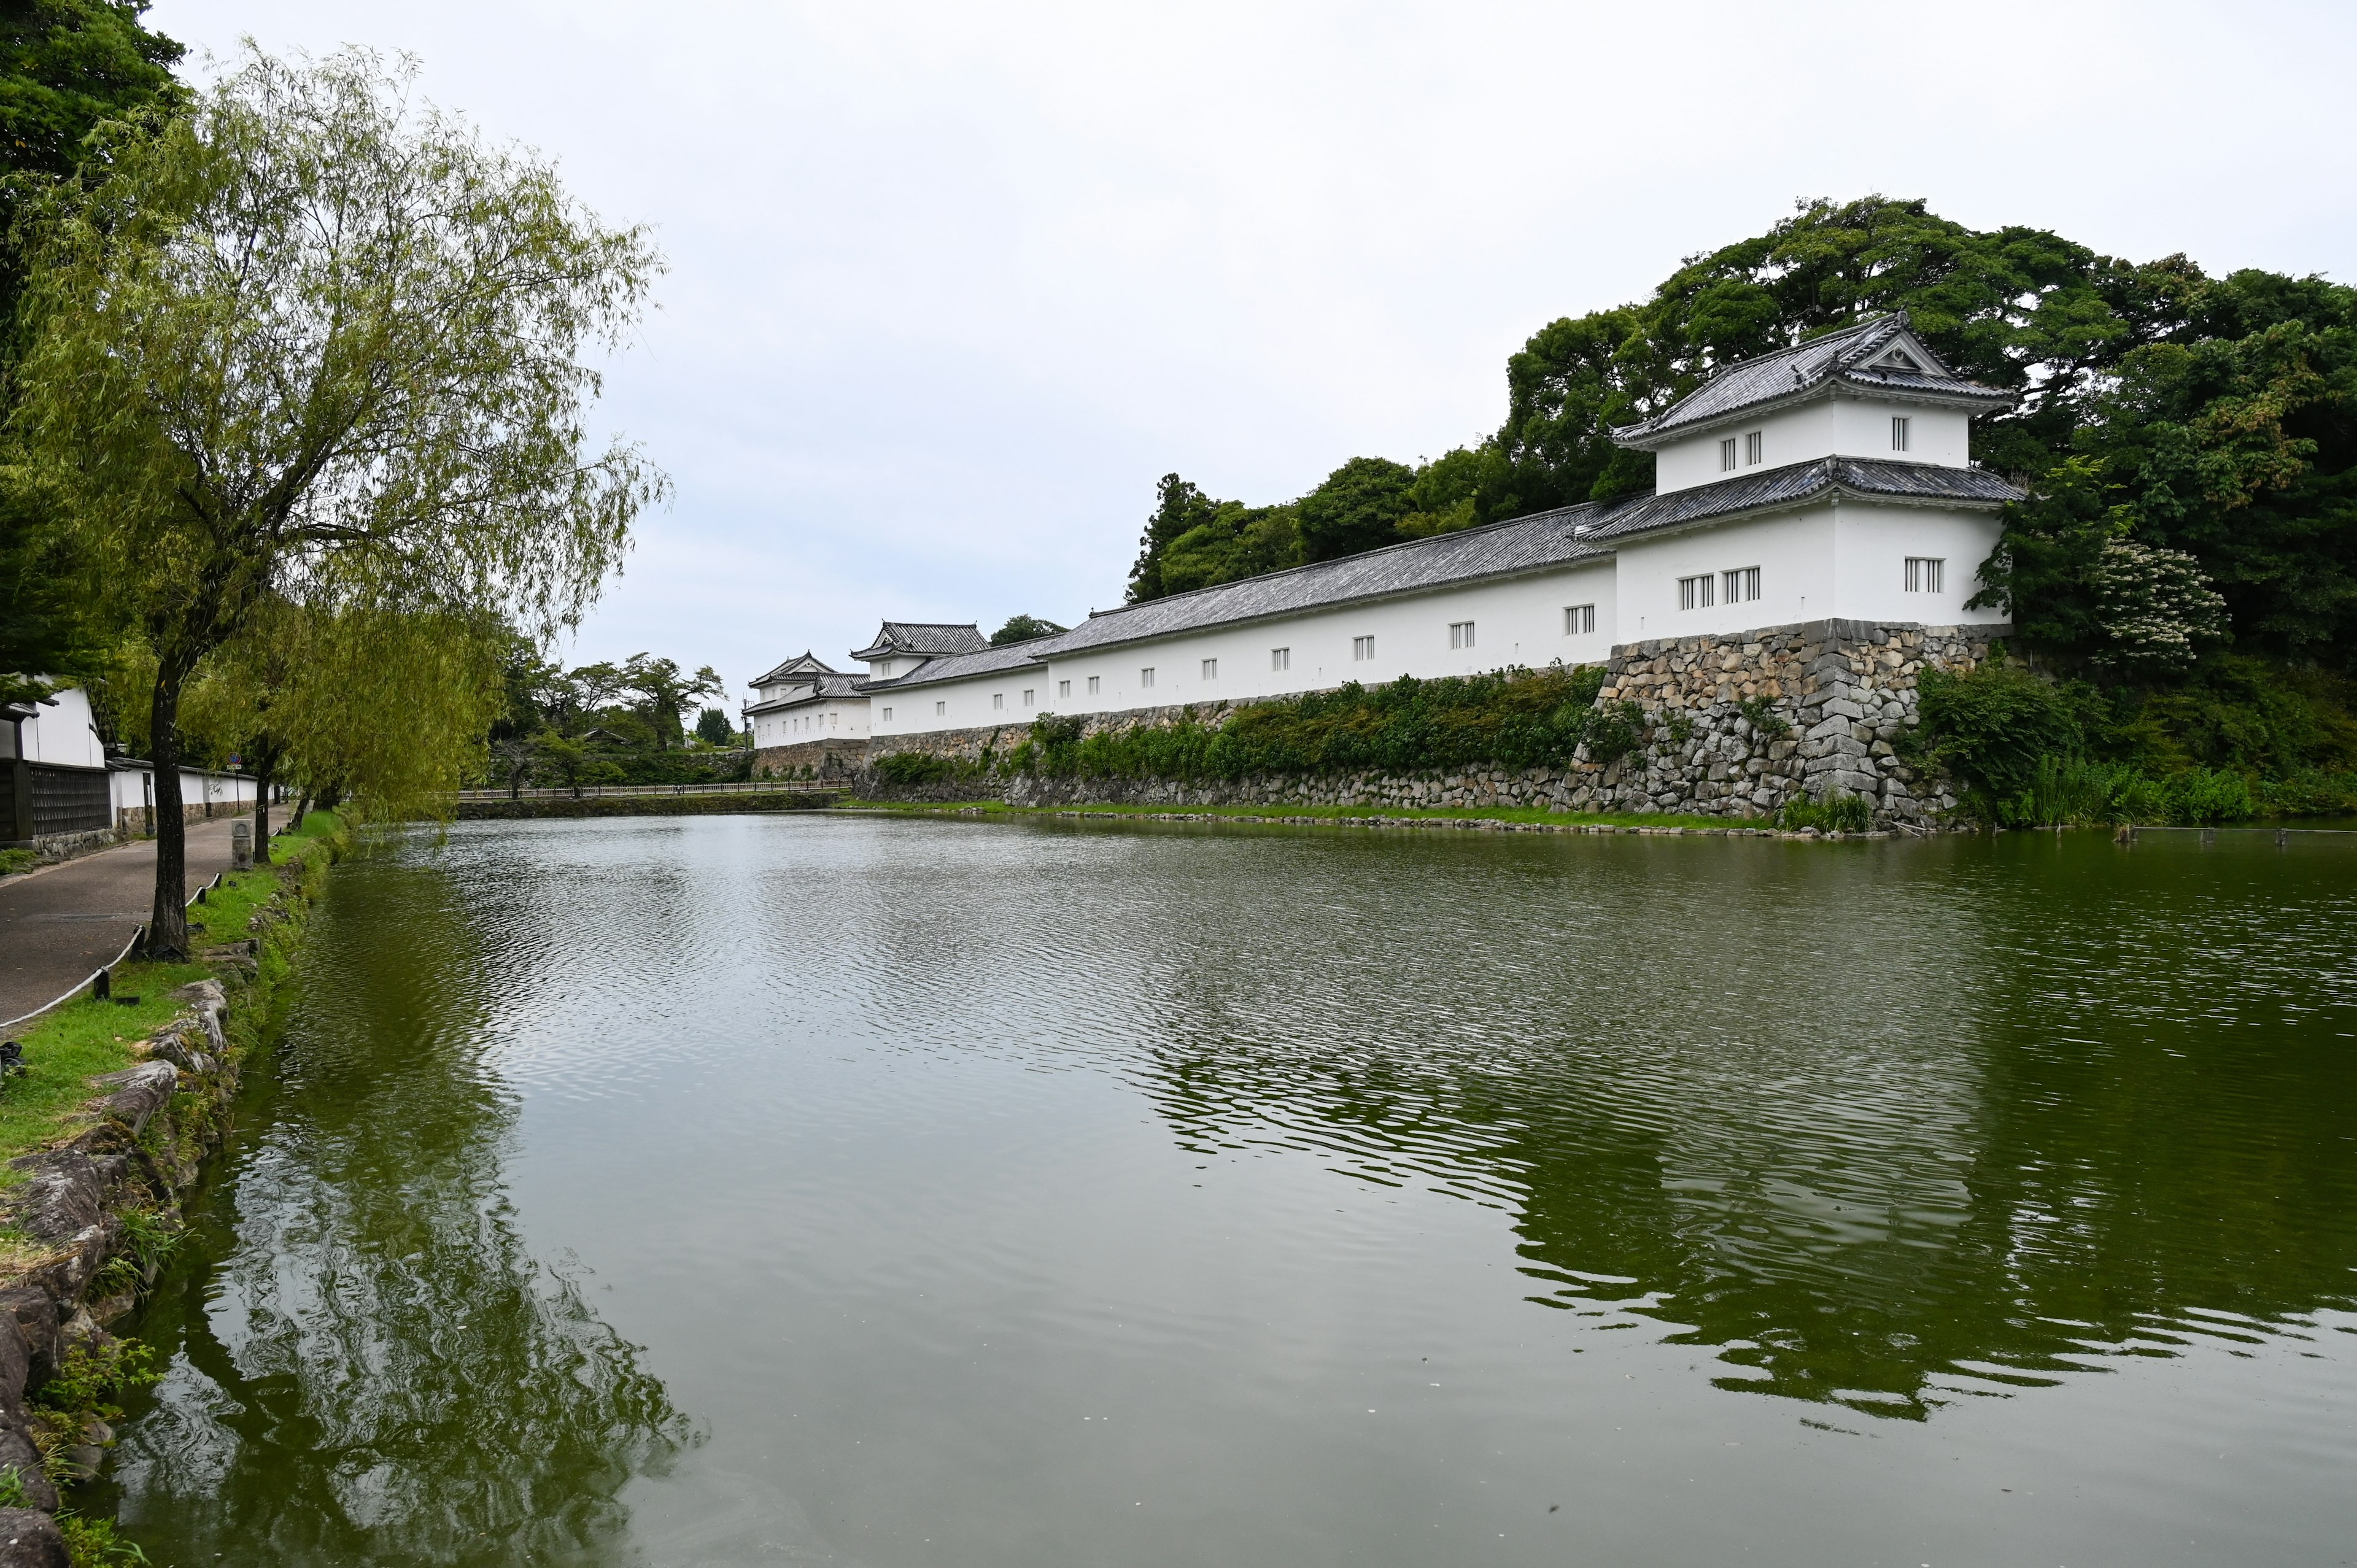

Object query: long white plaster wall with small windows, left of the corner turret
[875,561,1619,736]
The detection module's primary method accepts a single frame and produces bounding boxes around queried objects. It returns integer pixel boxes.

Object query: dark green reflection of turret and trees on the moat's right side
[1126,835,2357,1419]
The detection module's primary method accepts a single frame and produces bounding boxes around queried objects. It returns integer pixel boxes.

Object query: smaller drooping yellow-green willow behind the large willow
[182,597,511,860]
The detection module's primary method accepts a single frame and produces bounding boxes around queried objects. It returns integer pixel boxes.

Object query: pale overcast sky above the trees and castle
[149,0,2357,700]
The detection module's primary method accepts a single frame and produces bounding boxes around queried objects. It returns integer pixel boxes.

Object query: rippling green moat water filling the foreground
[85,816,2357,1568]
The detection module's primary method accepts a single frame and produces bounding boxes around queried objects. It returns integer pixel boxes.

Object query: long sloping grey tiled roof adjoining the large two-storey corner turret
[1037,502,1603,658]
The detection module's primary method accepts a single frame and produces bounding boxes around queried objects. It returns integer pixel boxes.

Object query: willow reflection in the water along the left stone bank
[101,863,688,1563]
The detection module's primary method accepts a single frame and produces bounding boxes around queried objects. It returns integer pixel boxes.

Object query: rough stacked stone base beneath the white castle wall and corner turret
[857,620,2008,828]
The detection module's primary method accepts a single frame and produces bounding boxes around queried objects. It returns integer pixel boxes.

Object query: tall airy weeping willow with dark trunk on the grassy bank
[14,50,667,957]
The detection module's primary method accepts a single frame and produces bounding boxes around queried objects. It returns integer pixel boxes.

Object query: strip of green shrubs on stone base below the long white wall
[1007,665,1603,781]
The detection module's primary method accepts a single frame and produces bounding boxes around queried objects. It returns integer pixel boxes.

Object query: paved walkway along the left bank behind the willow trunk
[0,811,255,1019]
